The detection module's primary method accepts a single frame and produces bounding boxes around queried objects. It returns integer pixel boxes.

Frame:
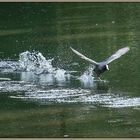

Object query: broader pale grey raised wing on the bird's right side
[104,47,130,64]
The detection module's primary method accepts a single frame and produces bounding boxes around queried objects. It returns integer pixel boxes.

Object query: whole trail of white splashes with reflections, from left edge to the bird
[0,51,100,88]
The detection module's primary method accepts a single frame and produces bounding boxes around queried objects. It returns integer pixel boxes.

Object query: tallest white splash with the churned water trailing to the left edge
[0,51,56,74]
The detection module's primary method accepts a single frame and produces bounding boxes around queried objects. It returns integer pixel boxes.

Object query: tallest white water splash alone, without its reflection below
[19,51,55,74]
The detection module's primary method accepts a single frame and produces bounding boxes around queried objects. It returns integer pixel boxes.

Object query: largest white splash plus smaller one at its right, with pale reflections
[19,51,70,85]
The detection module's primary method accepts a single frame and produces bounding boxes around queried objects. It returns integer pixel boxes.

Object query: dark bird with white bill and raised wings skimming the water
[70,47,130,77]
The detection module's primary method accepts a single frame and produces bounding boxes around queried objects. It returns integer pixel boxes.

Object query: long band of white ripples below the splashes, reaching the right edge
[4,80,140,108]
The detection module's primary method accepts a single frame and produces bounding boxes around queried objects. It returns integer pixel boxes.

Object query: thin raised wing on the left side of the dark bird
[70,47,99,65]
